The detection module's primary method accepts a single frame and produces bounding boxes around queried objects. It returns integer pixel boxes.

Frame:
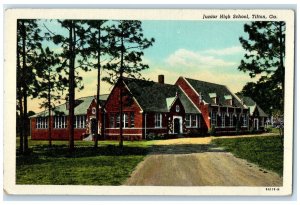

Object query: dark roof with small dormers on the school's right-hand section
[185,78,245,108]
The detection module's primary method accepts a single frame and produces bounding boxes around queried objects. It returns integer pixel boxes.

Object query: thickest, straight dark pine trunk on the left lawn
[68,20,75,153]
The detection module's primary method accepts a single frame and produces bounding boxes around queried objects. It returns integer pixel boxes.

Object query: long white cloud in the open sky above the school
[165,49,237,70]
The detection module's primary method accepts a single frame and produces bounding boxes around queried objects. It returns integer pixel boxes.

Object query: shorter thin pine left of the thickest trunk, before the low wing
[35,47,63,146]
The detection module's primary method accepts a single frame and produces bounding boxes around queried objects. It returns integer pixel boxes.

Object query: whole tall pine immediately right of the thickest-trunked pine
[87,20,108,148]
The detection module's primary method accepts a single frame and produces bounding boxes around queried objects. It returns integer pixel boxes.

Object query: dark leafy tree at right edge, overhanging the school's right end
[238,21,285,111]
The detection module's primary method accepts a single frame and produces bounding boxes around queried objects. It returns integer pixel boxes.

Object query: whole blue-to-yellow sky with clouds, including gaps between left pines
[29,20,256,111]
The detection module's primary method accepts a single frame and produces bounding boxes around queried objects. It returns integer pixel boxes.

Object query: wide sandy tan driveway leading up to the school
[125,134,282,186]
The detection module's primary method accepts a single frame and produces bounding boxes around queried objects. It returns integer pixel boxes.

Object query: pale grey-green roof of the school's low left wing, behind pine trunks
[31,94,108,117]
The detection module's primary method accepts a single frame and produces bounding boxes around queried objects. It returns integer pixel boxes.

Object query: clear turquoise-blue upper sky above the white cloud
[143,21,245,61]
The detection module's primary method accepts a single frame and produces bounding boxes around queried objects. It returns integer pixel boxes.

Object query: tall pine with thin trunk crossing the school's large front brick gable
[104,20,154,148]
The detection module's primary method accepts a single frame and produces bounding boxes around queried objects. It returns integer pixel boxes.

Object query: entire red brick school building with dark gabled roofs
[31,75,260,140]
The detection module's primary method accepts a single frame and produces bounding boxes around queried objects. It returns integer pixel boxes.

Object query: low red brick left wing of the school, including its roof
[30,95,108,140]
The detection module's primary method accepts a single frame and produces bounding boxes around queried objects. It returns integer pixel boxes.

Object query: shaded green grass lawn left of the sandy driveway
[16,139,154,185]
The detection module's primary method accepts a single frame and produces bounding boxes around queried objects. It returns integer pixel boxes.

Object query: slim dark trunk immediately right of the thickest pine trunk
[94,25,103,148]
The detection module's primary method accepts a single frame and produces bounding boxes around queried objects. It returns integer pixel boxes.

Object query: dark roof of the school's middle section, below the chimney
[124,78,199,113]
